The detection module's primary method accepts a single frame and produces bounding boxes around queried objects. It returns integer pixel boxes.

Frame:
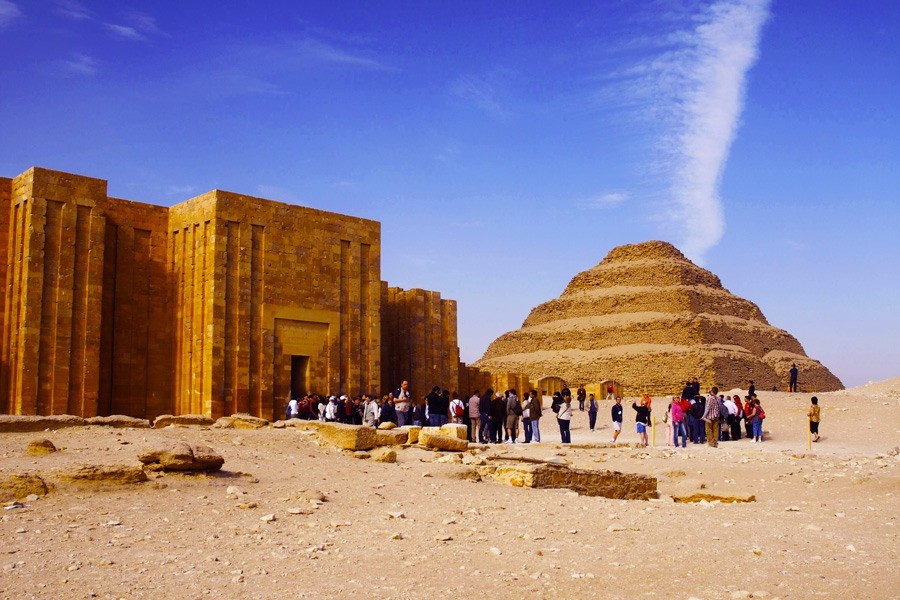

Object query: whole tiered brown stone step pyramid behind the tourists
[475,241,843,395]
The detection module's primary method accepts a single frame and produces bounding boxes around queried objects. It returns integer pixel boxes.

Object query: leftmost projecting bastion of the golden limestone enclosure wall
[0,168,106,417]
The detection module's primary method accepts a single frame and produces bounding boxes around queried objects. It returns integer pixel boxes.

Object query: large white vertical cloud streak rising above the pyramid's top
[647,0,770,261]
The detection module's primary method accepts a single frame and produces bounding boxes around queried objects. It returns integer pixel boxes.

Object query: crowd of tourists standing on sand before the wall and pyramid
[285,378,820,448]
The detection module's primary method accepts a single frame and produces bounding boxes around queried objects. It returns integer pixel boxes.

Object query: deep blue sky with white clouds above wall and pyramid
[0,0,900,385]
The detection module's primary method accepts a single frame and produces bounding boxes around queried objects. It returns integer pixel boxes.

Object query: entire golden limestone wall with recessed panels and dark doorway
[0,168,459,419]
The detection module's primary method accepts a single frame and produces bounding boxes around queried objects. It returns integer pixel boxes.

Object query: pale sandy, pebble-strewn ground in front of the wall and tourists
[0,379,900,599]
